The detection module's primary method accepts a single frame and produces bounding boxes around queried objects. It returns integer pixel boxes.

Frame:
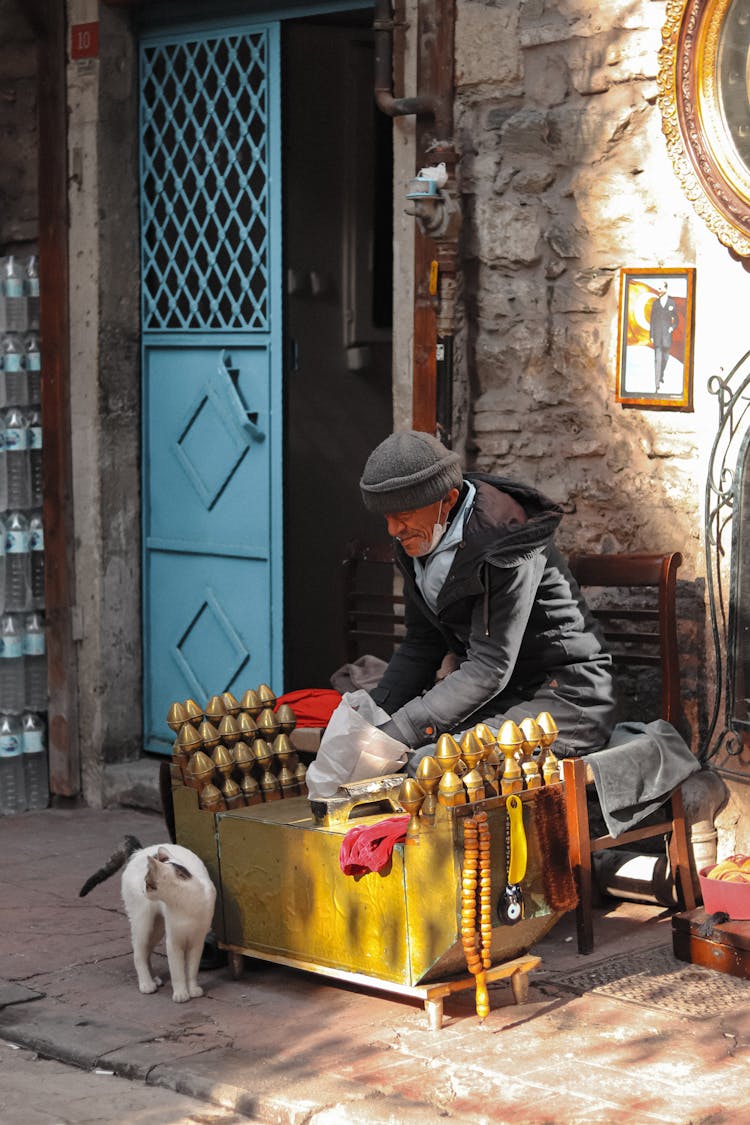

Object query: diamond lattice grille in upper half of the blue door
[141,32,269,331]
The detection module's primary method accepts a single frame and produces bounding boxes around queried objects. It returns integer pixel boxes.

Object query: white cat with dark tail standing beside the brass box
[79,836,216,1004]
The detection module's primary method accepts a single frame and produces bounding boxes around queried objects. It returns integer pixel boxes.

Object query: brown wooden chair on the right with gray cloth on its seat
[562,552,695,953]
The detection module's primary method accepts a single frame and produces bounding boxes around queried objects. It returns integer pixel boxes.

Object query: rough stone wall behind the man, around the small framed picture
[455,0,750,747]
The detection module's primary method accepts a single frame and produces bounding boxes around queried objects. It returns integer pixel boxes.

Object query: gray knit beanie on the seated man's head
[360,430,463,515]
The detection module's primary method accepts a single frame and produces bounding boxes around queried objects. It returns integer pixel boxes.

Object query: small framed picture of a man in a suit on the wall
[615,267,695,411]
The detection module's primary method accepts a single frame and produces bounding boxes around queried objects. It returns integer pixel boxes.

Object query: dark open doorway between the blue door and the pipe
[282,12,392,691]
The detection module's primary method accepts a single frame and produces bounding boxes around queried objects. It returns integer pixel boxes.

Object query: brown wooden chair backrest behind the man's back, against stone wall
[569,551,683,728]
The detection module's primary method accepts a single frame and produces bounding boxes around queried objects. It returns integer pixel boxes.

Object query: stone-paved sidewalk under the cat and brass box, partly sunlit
[0,810,750,1125]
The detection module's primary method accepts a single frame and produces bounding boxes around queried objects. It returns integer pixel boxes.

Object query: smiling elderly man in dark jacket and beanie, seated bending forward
[360,431,615,771]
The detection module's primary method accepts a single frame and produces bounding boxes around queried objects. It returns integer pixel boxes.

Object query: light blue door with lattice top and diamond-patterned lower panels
[141,23,283,752]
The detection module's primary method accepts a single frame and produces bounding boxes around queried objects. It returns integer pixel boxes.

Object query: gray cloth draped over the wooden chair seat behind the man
[584,719,701,837]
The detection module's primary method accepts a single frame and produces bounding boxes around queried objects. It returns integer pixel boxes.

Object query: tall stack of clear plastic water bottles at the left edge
[0,255,48,816]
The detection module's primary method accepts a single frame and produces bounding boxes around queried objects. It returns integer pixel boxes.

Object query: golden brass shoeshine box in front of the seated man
[173,785,560,986]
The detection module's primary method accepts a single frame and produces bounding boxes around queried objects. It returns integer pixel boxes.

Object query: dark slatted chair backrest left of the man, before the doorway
[342,540,405,663]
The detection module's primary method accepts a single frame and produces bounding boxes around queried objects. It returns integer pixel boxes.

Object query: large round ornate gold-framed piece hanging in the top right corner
[658,0,750,258]
